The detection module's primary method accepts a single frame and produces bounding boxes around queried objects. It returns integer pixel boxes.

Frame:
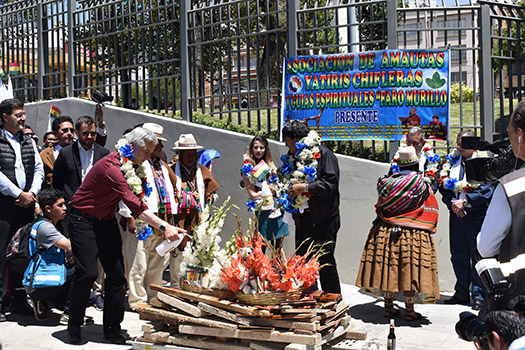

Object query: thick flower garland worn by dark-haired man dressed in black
[276,130,321,213]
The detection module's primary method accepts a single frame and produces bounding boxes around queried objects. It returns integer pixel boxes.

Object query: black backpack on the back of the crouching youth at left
[6,219,43,275]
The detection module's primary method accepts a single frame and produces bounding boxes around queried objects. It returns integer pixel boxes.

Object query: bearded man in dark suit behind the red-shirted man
[53,116,109,203]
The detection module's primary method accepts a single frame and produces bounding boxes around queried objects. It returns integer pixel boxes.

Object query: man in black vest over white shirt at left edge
[0,99,44,322]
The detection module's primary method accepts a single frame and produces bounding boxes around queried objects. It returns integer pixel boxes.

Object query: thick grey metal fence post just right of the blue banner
[474,5,494,142]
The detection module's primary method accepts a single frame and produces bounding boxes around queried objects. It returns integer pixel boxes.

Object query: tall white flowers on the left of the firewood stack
[179,197,237,288]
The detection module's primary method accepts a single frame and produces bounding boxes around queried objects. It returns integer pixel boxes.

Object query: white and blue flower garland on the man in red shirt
[116,138,153,241]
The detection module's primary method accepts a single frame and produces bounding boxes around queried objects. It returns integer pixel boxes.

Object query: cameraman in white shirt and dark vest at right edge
[477,101,525,296]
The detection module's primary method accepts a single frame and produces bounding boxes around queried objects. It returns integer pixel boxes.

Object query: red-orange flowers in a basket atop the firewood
[222,220,323,294]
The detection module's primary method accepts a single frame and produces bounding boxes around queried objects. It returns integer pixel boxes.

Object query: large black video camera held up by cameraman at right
[461,136,516,184]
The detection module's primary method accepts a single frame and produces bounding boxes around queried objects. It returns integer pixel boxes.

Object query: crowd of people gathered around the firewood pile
[0,99,525,344]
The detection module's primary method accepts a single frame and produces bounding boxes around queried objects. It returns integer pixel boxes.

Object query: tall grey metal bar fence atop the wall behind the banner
[0,0,525,158]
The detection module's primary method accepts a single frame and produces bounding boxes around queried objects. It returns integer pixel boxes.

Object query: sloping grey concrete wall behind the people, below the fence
[26,99,455,291]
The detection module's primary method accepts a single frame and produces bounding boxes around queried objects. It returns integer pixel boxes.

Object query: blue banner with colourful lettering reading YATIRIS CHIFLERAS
[281,50,450,141]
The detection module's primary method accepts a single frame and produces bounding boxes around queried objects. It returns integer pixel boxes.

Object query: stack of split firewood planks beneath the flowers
[131,285,366,350]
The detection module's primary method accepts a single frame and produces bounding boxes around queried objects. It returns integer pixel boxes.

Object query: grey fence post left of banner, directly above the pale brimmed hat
[180,0,191,121]
